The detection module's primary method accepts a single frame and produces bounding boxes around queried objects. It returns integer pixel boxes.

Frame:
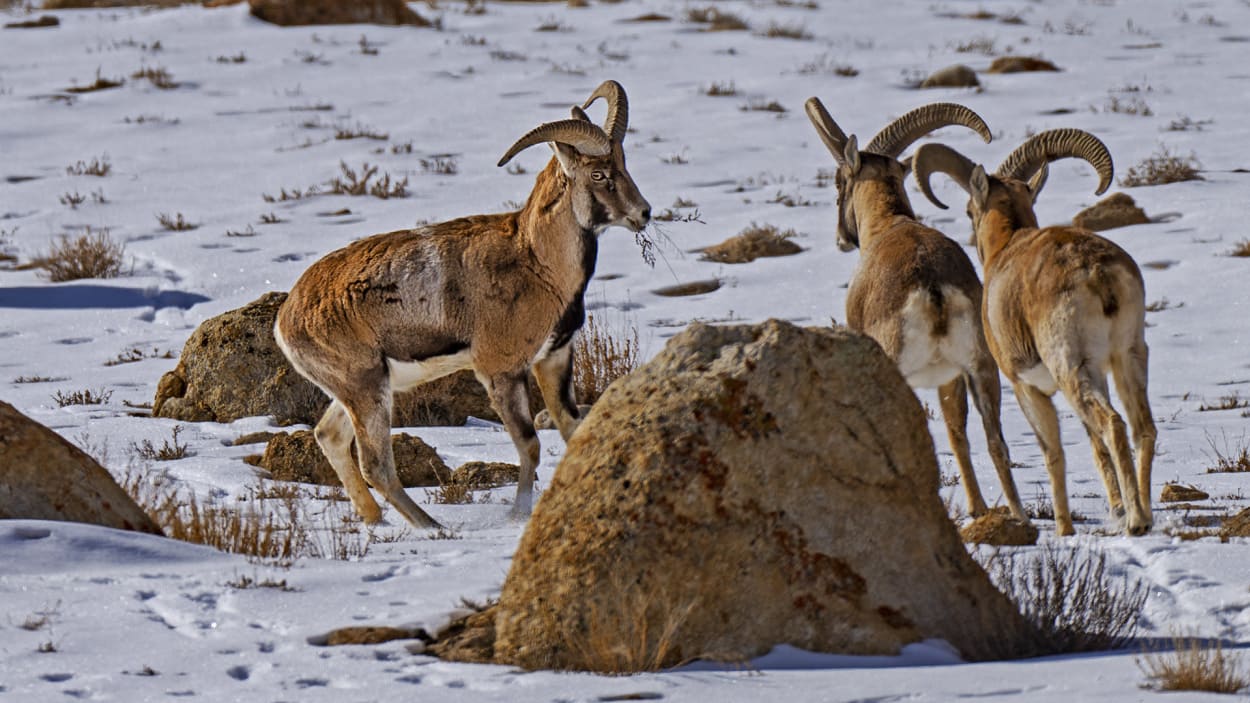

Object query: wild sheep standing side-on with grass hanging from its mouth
[274,80,651,528]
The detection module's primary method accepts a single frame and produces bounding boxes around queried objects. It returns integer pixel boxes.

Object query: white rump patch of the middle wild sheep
[896,286,978,388]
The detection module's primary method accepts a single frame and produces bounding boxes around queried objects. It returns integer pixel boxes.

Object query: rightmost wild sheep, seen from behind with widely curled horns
[914,129,1155,535]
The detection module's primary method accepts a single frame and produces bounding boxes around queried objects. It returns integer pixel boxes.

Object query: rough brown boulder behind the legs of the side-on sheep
[153,293,541,427]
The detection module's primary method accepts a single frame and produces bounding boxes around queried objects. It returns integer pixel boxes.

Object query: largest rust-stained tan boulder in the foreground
[434,320,1034,670]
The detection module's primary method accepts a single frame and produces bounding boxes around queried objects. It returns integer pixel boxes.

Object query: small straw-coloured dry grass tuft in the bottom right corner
[1138,634,1250,693]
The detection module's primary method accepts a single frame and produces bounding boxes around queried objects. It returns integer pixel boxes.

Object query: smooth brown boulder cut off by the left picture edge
[0,402,163,534]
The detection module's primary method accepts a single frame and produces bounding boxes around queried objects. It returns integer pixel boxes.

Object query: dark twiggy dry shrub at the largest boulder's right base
[985,544,1149,655]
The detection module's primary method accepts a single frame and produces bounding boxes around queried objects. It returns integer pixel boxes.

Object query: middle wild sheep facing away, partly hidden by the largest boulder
[806,98,1029,523]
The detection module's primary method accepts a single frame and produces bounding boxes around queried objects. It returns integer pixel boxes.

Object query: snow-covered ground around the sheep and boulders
[0,0,1250,703]
